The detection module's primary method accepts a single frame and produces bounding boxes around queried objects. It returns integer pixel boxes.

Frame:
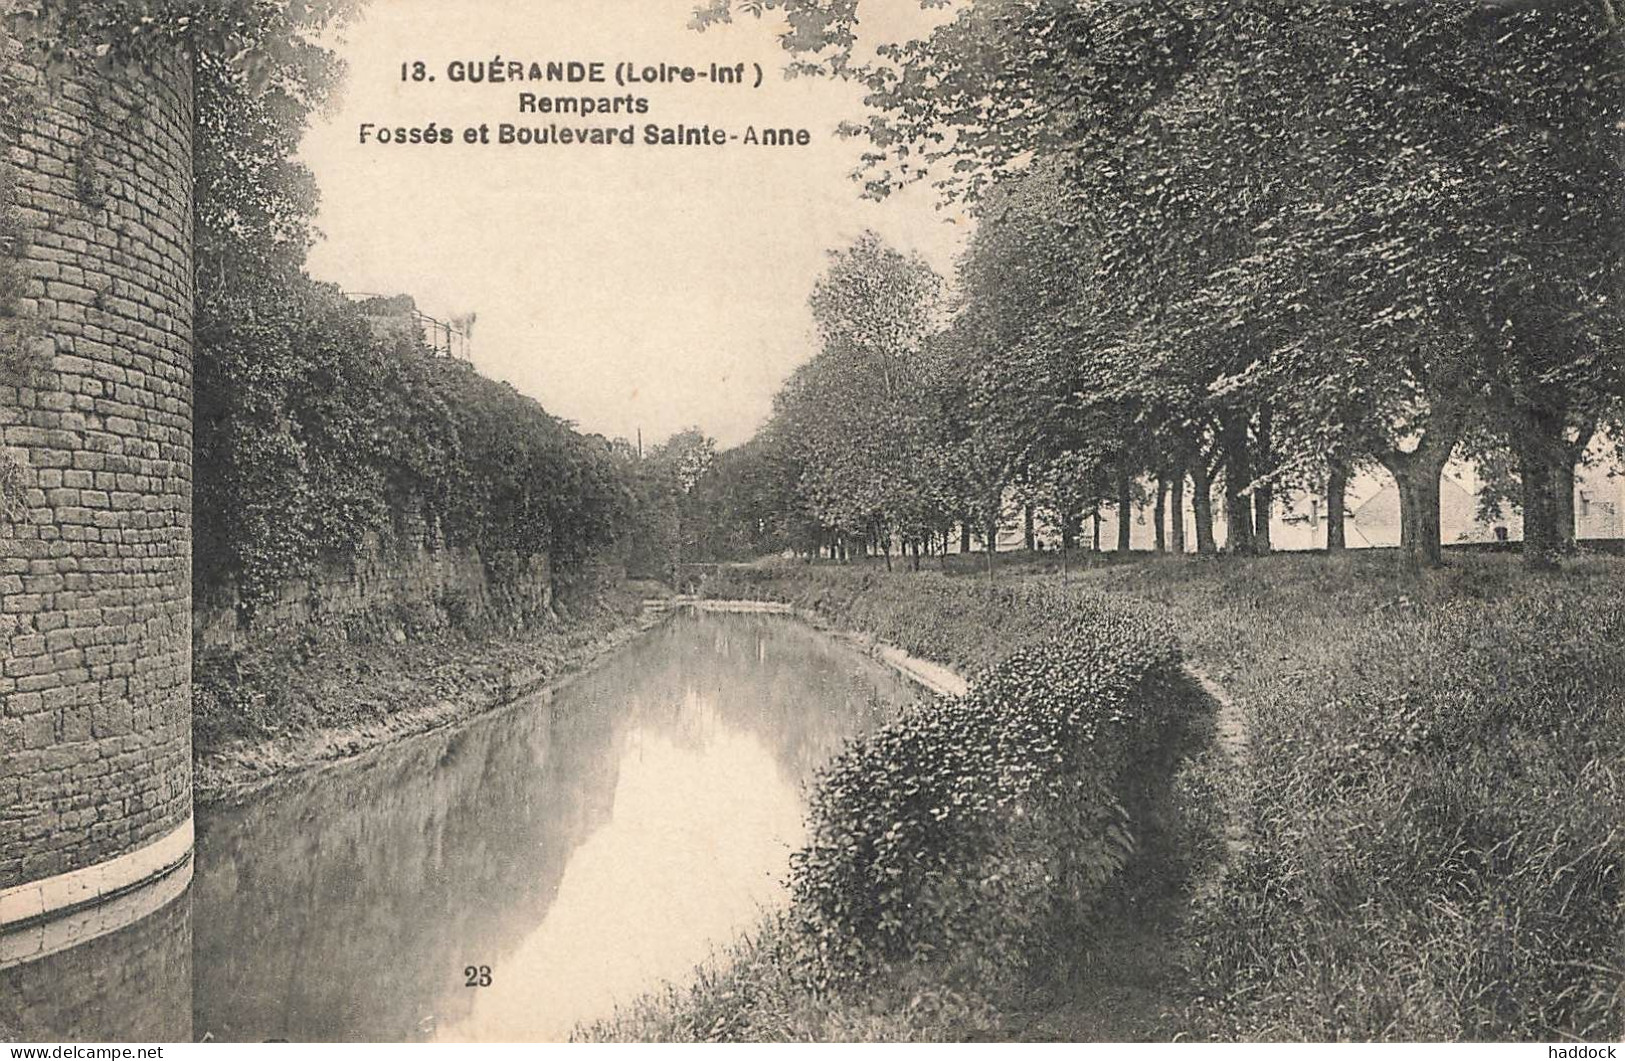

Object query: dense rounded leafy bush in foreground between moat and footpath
[790,617,1175,978]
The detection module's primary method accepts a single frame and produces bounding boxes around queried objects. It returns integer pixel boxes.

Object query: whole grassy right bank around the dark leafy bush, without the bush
[588,554,1625,1040]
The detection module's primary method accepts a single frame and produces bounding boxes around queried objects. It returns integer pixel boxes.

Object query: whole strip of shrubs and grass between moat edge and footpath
[585,567,1196,1040]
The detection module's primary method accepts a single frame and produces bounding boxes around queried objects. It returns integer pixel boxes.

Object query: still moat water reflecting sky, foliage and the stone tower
[0,614,917,1042]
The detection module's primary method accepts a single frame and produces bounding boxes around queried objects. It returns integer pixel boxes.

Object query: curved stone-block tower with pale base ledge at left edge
[0,29,193,929]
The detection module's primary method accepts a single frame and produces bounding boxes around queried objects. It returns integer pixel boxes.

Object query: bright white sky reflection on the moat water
[439,691,801,1042]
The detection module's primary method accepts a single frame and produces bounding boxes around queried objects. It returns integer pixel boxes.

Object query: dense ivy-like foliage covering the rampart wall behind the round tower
[193,281,626,608]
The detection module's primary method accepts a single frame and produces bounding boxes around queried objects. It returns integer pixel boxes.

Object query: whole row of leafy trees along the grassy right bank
[700,0,1625,565]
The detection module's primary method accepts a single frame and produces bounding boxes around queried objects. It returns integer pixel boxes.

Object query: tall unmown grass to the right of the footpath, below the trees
[1059,556,1625,1040]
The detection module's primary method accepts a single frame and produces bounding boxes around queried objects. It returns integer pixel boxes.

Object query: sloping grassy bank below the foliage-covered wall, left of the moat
[192,578,642,803]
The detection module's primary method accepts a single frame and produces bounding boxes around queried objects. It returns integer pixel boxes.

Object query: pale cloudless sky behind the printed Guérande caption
[302,0,969,445]
